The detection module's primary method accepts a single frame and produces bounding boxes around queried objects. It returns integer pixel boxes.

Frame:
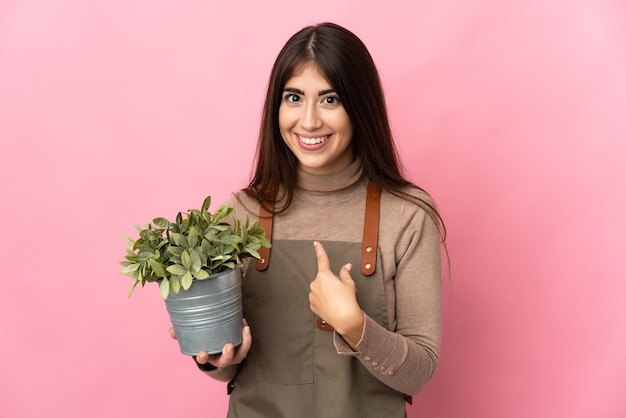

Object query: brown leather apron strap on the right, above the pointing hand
[361,183,380,276]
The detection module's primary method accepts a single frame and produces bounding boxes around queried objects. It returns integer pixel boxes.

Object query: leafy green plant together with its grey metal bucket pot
[120,196,271,355]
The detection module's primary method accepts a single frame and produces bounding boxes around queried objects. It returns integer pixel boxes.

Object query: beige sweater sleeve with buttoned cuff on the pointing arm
[334,204,441,395]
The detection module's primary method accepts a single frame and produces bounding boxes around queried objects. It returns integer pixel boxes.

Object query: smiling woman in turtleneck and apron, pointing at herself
[173,23,443,418]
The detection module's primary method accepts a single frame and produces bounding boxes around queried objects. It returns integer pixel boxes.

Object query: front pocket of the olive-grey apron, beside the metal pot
[252,297,314,385]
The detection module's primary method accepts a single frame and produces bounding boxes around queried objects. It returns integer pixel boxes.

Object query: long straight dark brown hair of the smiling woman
[244,23,445,239]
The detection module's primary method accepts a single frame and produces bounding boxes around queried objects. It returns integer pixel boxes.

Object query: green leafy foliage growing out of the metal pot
[120,196,271,299]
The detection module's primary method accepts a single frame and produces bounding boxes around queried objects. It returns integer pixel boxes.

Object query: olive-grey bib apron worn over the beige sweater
[228,188,406,418]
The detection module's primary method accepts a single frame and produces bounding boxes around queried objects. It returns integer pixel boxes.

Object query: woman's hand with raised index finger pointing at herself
[309,241,365,351]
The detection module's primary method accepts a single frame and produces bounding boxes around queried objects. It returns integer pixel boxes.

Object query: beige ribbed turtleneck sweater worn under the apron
[207,160,441,395]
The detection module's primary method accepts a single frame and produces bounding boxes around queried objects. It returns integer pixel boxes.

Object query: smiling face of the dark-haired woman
[278,64,354,175]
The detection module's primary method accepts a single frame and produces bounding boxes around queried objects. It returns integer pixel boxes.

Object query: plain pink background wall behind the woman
[0,0,626,418]
